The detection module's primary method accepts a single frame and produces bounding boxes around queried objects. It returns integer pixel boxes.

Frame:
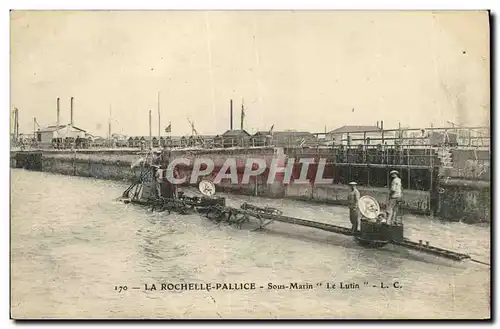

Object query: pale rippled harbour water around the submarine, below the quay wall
[11,169,490,319]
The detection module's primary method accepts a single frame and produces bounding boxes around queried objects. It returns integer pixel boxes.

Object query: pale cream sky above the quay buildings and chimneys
[10,11,490,136]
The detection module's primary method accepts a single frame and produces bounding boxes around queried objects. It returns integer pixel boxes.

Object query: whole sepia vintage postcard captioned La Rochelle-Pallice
[10,10,491,320]
